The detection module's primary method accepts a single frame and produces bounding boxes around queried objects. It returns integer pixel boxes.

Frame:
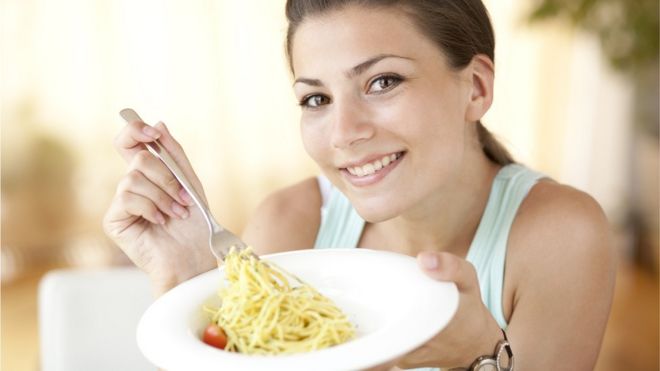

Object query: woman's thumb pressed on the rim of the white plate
[417,251,479,292]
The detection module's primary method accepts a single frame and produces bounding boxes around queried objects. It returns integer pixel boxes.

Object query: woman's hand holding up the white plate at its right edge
[396,251,502,369]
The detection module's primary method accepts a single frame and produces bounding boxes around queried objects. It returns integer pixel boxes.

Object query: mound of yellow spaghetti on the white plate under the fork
[204,248,355,355]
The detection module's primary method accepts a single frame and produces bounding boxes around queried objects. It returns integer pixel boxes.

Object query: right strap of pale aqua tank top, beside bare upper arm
[467,164,546,328]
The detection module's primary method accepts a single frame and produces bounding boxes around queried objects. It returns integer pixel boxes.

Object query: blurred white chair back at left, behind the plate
[39,267,156,371]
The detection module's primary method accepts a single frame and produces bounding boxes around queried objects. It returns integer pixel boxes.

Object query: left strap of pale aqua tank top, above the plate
[314,176,364,249]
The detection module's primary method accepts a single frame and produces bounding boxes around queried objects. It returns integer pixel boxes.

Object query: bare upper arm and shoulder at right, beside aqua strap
[506,182,616,370]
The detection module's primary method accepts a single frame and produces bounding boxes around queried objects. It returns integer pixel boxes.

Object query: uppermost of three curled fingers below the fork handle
[129,150,192,206]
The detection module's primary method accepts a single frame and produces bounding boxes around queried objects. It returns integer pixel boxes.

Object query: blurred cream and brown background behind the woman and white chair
[0,0,659,371]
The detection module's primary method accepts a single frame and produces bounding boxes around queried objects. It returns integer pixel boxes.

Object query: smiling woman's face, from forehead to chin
[292,6,471,222]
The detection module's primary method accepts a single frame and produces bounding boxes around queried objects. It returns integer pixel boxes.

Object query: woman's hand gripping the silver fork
[103,121,216,293]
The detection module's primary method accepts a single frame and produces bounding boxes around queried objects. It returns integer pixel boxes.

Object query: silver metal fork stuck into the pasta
[119,108,249,263]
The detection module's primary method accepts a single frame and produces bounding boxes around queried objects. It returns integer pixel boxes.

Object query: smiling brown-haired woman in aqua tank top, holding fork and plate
[104,0,614,370]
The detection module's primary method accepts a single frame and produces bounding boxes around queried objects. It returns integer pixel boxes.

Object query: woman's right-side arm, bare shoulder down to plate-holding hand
[395,181,615,370]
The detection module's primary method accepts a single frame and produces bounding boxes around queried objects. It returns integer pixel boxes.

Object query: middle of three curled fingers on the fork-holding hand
[118,169,190,219]
